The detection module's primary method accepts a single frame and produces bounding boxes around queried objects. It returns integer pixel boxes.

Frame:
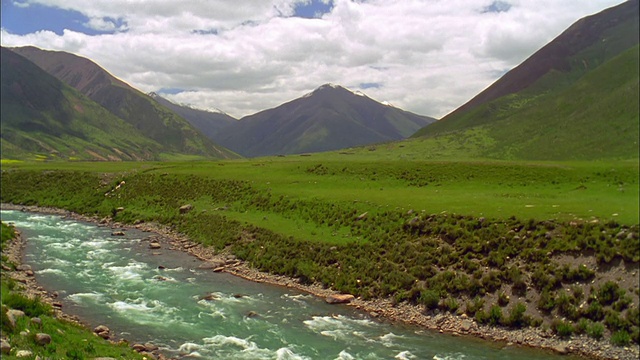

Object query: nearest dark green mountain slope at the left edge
[0,47,162,160]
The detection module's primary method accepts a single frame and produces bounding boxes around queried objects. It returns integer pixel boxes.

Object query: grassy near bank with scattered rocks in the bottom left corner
[0,223,142,359]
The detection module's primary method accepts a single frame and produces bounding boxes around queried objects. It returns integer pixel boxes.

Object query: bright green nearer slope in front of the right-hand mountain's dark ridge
[410,46,640,160]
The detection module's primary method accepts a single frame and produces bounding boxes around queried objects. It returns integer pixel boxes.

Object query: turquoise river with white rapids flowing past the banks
[2,210,559,359]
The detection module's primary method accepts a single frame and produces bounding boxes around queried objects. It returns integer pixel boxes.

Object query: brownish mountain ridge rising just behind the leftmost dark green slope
[11,46,237,158]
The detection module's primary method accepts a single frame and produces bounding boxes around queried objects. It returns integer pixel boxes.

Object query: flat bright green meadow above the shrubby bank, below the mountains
[3,154,639,224]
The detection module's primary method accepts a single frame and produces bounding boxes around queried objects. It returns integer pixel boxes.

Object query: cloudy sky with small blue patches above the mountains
[1,0,623,118]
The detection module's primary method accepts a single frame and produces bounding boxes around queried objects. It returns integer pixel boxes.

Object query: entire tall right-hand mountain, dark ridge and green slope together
[413,0,639,160]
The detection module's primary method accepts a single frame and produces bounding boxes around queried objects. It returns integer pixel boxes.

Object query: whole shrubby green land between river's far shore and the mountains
[1,159,640,345]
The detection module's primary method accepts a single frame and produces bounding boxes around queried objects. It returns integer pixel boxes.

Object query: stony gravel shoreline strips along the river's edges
[2,204,638,359]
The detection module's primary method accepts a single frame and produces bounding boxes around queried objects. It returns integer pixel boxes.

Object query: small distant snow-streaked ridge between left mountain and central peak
[149,92,238,141]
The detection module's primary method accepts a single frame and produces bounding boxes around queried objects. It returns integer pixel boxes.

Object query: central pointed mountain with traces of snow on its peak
[215,84,435,157]
